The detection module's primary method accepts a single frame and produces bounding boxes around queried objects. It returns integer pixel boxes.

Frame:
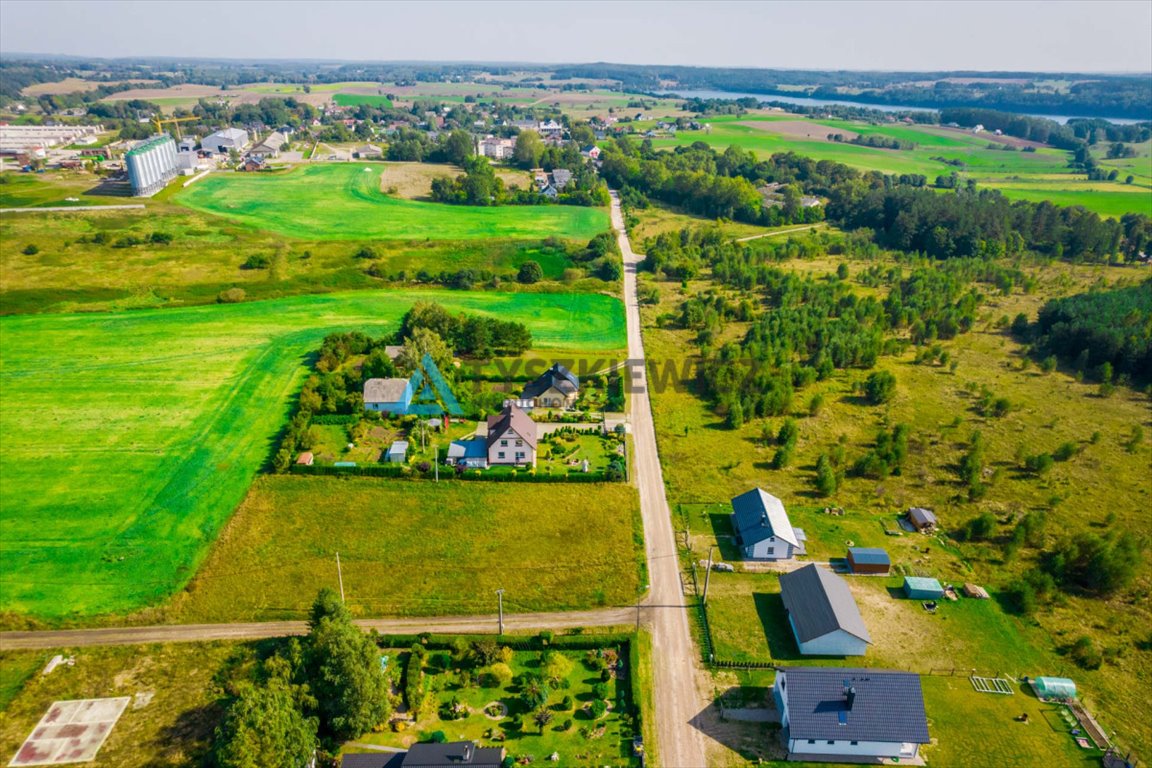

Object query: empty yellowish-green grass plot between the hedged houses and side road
[167,476,642,623]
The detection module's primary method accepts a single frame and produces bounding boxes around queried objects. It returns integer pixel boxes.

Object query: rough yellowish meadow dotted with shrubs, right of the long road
[644,257,1152,750]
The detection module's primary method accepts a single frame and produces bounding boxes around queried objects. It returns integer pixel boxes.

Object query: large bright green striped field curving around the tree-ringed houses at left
[0,291,624,623]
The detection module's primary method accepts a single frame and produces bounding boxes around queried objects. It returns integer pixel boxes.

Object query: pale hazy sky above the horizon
[0,0,1152,73]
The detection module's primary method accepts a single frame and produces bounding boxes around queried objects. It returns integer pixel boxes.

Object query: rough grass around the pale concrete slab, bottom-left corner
[0,642,247,768]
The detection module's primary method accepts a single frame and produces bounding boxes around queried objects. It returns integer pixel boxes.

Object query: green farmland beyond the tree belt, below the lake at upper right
[653,113,1152,216]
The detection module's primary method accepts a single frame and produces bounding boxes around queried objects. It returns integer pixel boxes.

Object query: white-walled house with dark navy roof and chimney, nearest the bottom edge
[772,667,930,762]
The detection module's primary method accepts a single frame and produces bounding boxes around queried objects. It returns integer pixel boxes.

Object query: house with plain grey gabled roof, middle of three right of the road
[780,564,872,656]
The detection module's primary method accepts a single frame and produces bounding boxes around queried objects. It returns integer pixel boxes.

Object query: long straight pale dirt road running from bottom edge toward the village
[612,192,706,768]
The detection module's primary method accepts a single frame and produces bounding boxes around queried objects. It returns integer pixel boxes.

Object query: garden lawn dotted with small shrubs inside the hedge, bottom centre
[346,651,634,766]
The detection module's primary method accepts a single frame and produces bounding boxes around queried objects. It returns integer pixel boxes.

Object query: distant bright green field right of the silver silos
[173,164,608,241]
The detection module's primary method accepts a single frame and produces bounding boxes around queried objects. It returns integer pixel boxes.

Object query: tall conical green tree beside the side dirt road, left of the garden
[306,591,389,736]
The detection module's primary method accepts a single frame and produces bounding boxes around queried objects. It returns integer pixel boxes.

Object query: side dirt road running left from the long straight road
[0,608,636,651]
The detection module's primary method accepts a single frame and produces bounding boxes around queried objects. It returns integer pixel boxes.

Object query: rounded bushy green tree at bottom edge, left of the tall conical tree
[215,676,317,768]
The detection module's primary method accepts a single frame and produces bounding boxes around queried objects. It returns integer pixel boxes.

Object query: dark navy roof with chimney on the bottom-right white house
[776,667,930,744]
